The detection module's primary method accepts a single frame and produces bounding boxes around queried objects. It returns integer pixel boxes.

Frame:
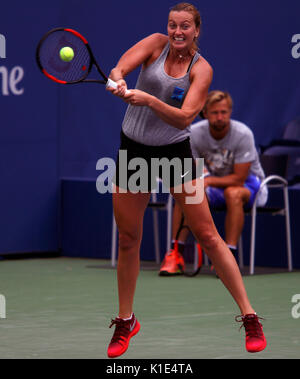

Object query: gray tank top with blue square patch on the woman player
[122,43,200,146]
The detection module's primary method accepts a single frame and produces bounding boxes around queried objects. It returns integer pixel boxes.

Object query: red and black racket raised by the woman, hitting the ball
[36,28,129,93]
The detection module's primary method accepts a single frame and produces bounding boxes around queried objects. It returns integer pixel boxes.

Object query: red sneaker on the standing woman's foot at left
[107,314,141,358]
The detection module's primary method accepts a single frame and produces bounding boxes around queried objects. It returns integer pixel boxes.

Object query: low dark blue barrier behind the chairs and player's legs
[62,179,300,269]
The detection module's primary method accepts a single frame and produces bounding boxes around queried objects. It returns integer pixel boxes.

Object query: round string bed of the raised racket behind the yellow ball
[38,30,92,82]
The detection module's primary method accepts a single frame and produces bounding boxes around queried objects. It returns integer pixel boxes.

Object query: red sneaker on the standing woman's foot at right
[235,313,267,353]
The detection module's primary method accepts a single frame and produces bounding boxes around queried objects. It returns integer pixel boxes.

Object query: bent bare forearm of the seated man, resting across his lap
[204,162,251,188]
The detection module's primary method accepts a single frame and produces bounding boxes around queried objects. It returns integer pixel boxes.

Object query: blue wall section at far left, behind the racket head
[0,1,59,253]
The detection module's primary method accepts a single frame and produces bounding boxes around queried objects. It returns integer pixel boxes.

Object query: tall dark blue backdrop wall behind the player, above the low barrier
[0,0,300,260]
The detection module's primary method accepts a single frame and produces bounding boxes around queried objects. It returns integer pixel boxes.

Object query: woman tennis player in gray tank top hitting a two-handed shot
[107,3,266,358]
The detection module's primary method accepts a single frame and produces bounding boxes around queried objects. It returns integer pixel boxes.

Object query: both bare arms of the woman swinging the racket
[108,33,213,129]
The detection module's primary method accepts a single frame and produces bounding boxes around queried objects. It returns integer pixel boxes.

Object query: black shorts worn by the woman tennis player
[113,132,202,193]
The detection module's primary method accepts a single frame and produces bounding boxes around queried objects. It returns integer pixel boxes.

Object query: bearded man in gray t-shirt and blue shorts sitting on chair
[159,91,268,276]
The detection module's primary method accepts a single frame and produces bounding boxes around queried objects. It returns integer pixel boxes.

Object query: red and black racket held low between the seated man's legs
[174,216,203,277]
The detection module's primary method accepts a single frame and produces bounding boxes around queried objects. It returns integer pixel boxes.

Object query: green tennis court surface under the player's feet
[0,258,300,359]
